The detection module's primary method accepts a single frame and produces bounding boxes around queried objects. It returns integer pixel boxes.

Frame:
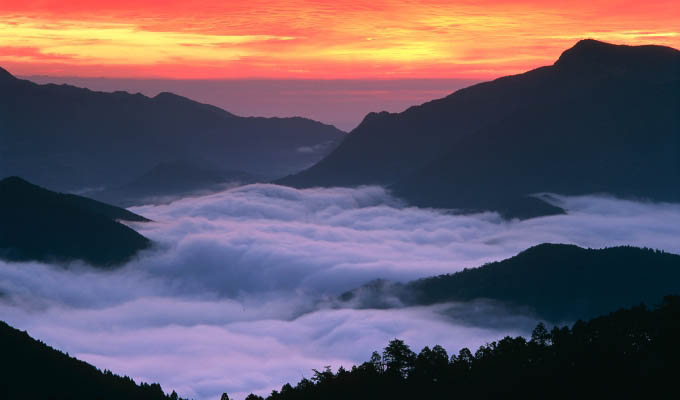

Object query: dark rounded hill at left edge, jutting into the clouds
[0,177,151,267]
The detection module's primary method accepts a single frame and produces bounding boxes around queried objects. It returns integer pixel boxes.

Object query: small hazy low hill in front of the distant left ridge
[91,162,257,207]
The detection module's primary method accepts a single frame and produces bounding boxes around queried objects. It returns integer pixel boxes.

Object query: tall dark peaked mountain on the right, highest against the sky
[279,40,680,218]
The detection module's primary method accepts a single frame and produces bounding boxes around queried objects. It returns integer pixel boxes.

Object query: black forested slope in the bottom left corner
[0,321,186,400]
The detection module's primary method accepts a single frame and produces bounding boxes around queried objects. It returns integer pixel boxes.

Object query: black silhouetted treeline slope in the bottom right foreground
[246,296,680,400]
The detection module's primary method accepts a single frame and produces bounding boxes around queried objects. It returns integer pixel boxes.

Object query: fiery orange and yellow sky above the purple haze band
[0,0,680,79]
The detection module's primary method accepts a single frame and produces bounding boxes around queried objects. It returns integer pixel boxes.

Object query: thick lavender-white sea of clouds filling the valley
[0,185,680,400]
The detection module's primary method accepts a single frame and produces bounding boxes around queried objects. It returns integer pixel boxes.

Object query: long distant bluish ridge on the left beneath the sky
[0,70,345,191]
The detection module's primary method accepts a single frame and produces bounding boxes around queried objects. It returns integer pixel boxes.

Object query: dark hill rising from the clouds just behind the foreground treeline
[341,244,680,322]
